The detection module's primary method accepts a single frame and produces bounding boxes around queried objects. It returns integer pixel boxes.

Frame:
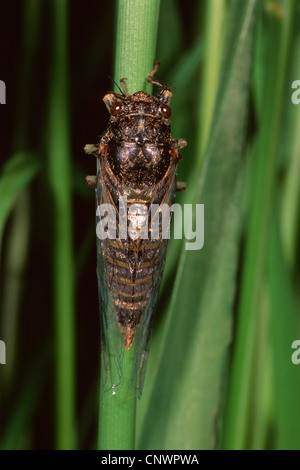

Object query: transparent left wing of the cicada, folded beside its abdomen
[96,160,124,394]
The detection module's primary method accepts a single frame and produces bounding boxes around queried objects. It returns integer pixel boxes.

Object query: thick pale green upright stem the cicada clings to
[98,0,159,450]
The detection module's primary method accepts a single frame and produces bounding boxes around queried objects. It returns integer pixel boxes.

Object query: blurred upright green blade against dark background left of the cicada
[47,0,76,449]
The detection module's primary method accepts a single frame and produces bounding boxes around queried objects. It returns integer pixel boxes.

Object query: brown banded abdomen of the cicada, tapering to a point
[104,231,165,349]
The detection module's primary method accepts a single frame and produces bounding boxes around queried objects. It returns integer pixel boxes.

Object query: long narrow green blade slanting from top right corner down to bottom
[223,1,295,449]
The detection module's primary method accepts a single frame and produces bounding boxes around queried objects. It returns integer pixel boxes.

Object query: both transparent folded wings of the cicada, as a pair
[96,153,176,398]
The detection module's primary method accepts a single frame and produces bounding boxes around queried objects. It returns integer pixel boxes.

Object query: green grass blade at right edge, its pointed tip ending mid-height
[268,204,300,450]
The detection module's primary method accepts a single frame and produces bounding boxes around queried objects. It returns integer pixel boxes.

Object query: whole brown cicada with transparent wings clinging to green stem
[85,62,186,398]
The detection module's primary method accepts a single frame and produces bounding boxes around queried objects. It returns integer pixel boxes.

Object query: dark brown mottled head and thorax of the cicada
[106,92,174,188]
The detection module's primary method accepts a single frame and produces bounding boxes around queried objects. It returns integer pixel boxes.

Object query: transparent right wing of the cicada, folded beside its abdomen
[130,165,176,398]
